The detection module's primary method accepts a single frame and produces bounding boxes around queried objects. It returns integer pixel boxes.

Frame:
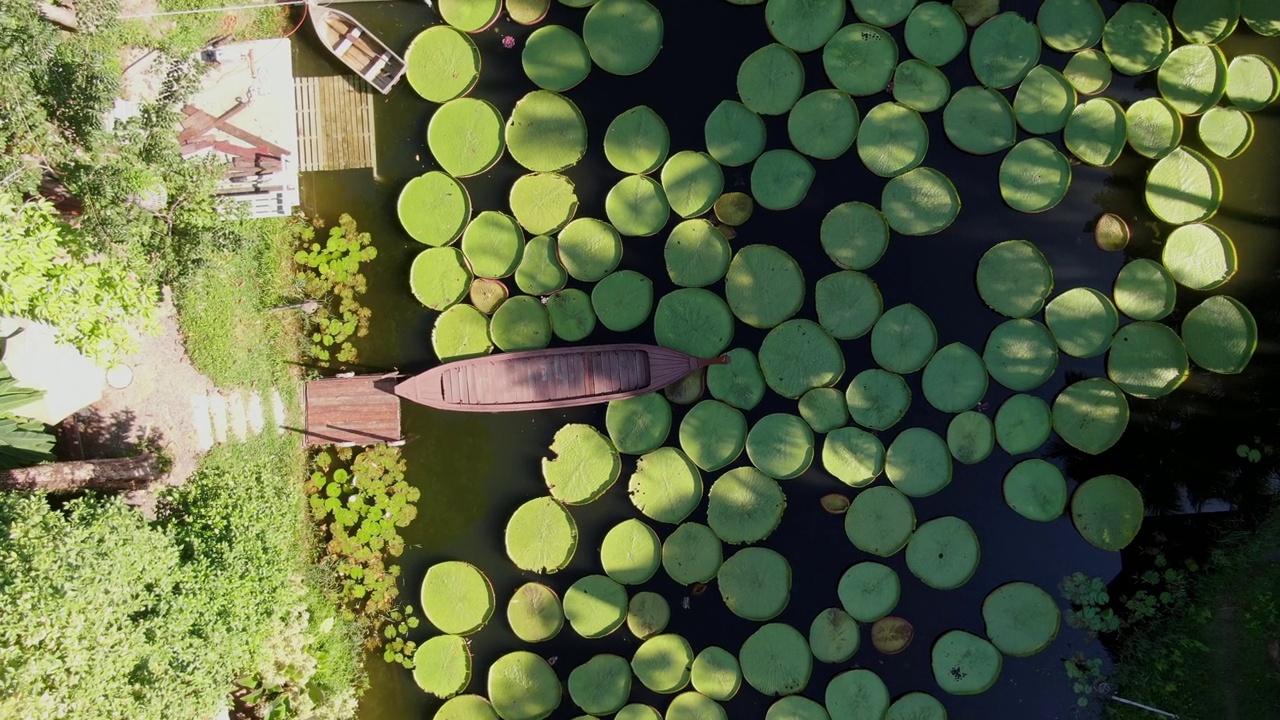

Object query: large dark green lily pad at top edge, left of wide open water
[582,0,663,76]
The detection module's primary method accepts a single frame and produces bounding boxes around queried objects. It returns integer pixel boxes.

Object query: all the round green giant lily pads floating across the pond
[398,0,1280,720]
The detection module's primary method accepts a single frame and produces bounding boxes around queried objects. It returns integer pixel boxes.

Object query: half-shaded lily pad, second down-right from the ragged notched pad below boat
[707,468,787,544]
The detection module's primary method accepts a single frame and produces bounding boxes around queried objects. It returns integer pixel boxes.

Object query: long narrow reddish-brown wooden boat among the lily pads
[396,343,728,413]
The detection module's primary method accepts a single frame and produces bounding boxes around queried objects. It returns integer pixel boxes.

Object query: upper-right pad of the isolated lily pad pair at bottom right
[982,583,1062,657]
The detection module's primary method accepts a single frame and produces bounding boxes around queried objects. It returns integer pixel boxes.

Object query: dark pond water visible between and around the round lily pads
[296,0,1280,720]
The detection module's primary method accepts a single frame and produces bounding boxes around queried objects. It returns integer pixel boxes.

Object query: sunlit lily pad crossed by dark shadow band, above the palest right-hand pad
[1146,147,1222,225]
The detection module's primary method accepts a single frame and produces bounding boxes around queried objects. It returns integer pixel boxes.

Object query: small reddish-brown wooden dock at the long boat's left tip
[305,373,403,445]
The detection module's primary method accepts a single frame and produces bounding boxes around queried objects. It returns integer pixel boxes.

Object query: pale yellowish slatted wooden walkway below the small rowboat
[293,76,375,173]
